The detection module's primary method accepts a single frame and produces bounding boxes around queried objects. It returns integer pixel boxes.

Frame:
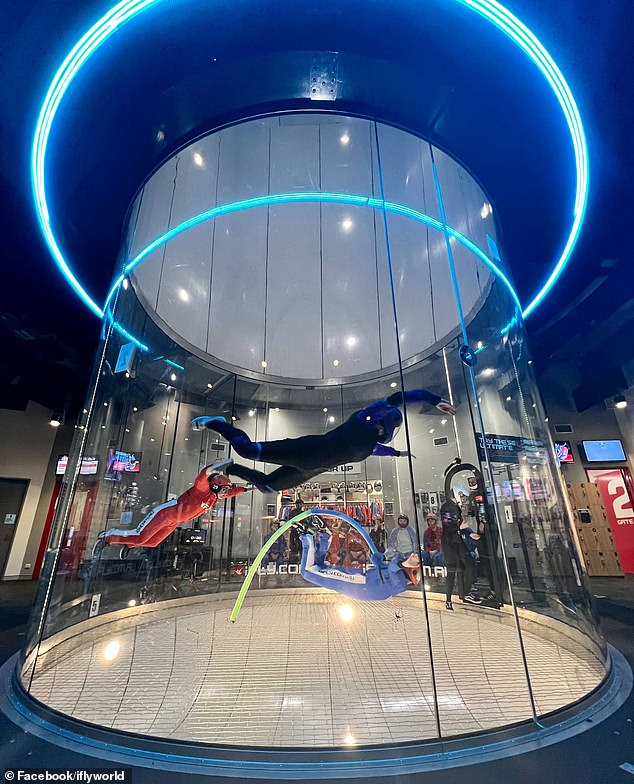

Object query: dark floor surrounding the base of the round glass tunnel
[0,578,634,784]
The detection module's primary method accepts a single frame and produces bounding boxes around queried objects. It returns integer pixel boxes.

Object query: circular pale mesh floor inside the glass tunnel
[25,589,605,747]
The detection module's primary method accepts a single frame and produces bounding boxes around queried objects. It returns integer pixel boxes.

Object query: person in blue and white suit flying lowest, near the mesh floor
[300,532,420,601]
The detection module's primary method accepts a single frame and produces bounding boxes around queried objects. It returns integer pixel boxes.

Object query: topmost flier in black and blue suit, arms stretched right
[192,389,456,493]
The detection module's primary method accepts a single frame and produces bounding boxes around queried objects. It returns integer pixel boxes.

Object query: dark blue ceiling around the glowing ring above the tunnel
[0,0,634,414]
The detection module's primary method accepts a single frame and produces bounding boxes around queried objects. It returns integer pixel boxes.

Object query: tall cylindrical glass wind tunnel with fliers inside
[21,111,607,756]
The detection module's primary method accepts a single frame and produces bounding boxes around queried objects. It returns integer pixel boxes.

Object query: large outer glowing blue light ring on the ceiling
[31,0,588,318]
